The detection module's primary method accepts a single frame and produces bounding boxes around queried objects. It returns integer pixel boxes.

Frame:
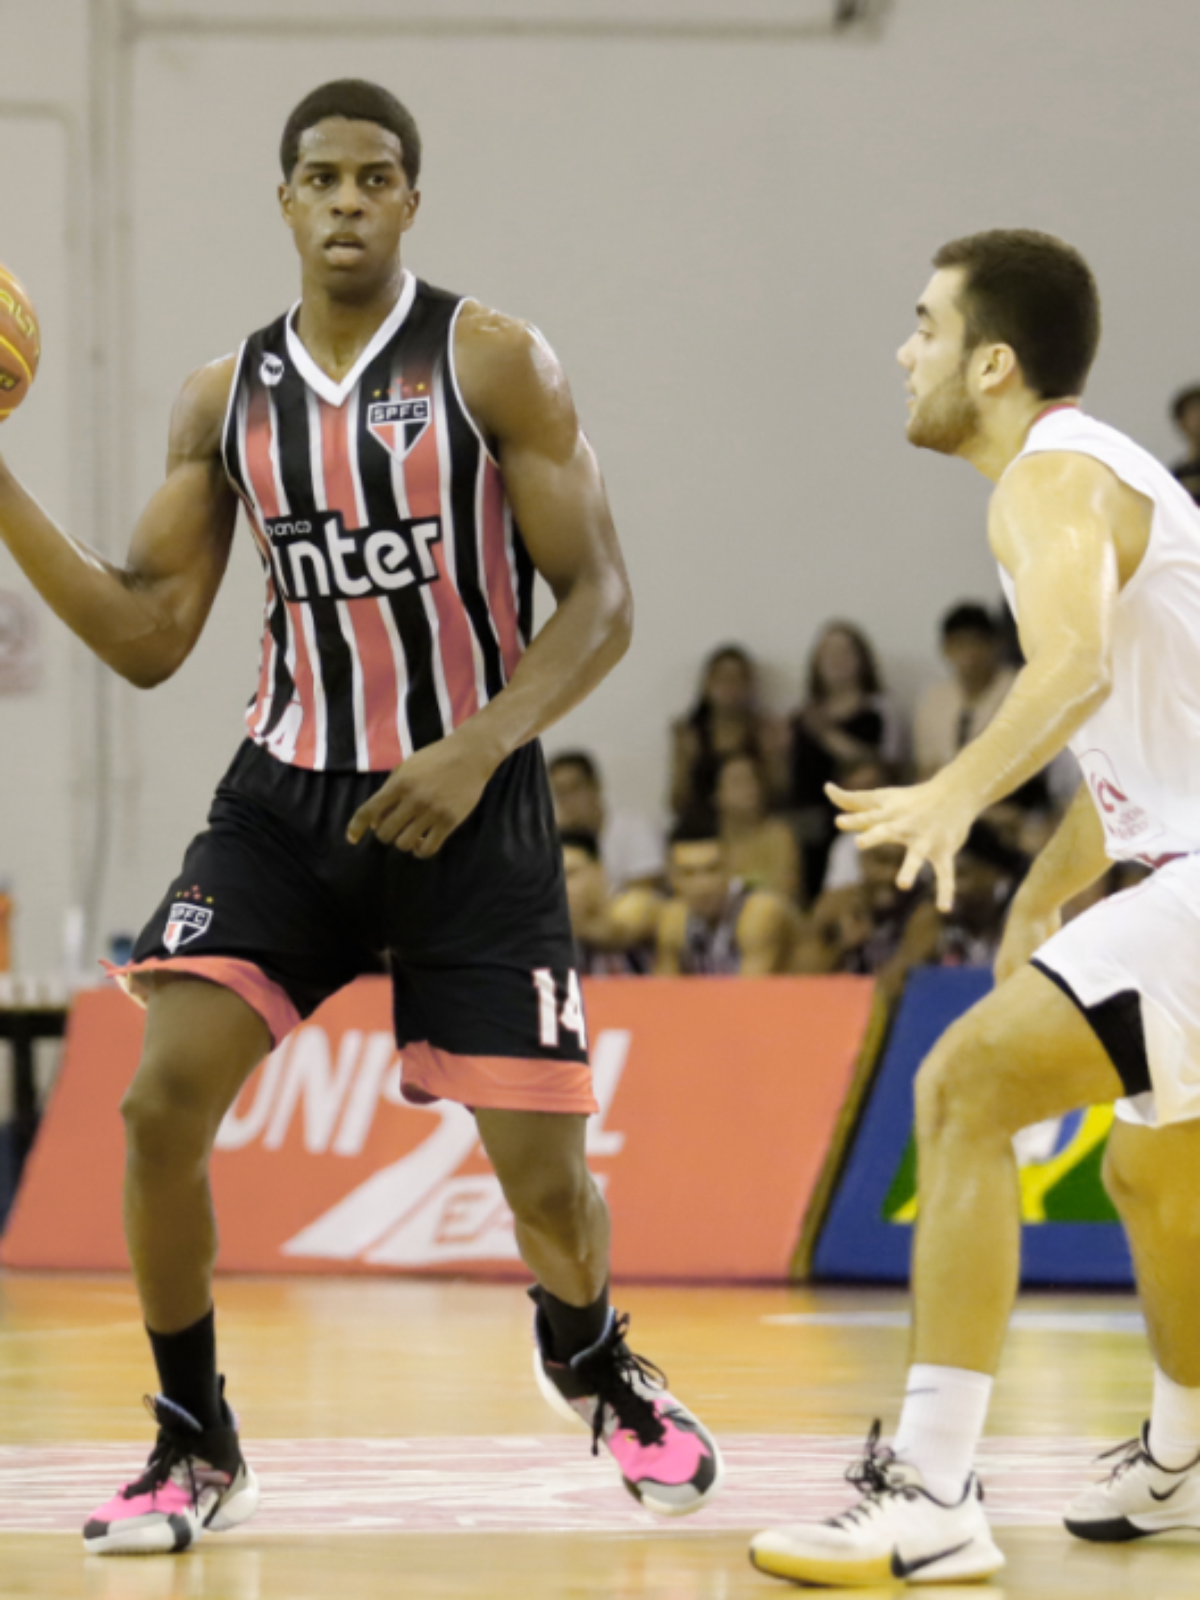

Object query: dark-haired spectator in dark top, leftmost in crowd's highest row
[670,645,784,818]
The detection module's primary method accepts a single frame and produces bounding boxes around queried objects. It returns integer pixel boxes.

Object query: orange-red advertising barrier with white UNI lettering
[0,978,872,1280]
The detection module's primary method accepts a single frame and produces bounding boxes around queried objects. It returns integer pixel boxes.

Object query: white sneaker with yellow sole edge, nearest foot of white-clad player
[750,1422,1005,1587]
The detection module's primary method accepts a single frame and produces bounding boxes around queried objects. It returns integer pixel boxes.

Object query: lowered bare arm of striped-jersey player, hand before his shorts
[349,302,632,856]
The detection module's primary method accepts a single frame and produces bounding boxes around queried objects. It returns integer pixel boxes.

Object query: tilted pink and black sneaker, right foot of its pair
[533,1309,723,1517]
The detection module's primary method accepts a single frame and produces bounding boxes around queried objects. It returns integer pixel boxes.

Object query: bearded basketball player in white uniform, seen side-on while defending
[752,230,1200,1586]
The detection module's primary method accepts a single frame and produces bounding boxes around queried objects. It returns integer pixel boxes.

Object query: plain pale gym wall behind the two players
[0,0,1200,949]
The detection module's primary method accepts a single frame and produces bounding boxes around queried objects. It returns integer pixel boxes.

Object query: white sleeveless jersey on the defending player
[1000,405,1200,862]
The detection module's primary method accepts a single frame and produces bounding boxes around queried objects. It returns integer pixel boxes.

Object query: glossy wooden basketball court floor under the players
[0,1274,1200,1600]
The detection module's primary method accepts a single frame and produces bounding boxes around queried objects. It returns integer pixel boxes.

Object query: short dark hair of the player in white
[933,227,1101,400]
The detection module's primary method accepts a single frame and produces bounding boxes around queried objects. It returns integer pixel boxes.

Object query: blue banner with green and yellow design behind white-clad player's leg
[813,968,1133,1286]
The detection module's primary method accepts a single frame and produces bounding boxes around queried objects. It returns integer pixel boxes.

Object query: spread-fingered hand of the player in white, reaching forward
[826,778,974,912]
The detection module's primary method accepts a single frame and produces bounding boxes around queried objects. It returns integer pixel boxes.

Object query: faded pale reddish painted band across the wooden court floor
[0,1434,1110,1542]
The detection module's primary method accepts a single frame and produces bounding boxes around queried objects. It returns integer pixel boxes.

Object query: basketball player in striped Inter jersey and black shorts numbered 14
[0,80,720,1554]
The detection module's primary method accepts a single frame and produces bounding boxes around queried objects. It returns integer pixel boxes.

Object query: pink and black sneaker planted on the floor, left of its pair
[83,1395,259,1555]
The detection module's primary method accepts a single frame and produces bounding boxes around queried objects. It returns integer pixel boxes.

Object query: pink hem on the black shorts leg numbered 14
[400,1042,600,1117]
